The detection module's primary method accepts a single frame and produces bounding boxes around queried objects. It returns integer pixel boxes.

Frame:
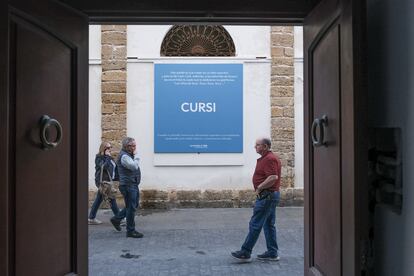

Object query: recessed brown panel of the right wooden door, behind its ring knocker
[310,25,341,275]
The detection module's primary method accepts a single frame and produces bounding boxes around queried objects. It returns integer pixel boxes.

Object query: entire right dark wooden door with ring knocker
[304,0,364,276]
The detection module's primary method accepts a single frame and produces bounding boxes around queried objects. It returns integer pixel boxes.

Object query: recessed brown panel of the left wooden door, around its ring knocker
[12,21,72,275]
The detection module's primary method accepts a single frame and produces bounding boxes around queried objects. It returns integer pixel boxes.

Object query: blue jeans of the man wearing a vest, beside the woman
[115,184,139,232]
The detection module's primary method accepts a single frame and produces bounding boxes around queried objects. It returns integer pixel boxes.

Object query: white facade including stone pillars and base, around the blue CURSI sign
[89,25,303,208]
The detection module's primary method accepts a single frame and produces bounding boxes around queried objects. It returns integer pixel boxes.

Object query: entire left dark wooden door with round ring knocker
[0,0,88,275]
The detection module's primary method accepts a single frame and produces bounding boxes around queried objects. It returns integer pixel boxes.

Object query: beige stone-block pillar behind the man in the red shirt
[270,27,295,188]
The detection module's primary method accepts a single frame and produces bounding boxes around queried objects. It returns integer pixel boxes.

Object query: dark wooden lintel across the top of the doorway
[61,0,319,25]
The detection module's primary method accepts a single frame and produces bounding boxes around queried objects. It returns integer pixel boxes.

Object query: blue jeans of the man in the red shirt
[241,192,280,256]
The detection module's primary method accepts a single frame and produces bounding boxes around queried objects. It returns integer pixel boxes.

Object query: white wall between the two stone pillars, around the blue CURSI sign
[127,26,271,190]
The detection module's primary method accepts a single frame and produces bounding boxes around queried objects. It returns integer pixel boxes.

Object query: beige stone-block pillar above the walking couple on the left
[101,25,127,154]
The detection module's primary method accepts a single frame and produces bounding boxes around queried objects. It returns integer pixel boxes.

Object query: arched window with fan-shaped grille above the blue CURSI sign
[161,25,236,57]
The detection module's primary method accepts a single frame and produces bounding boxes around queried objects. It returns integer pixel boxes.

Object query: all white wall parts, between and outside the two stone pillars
[89,25,303,193]
